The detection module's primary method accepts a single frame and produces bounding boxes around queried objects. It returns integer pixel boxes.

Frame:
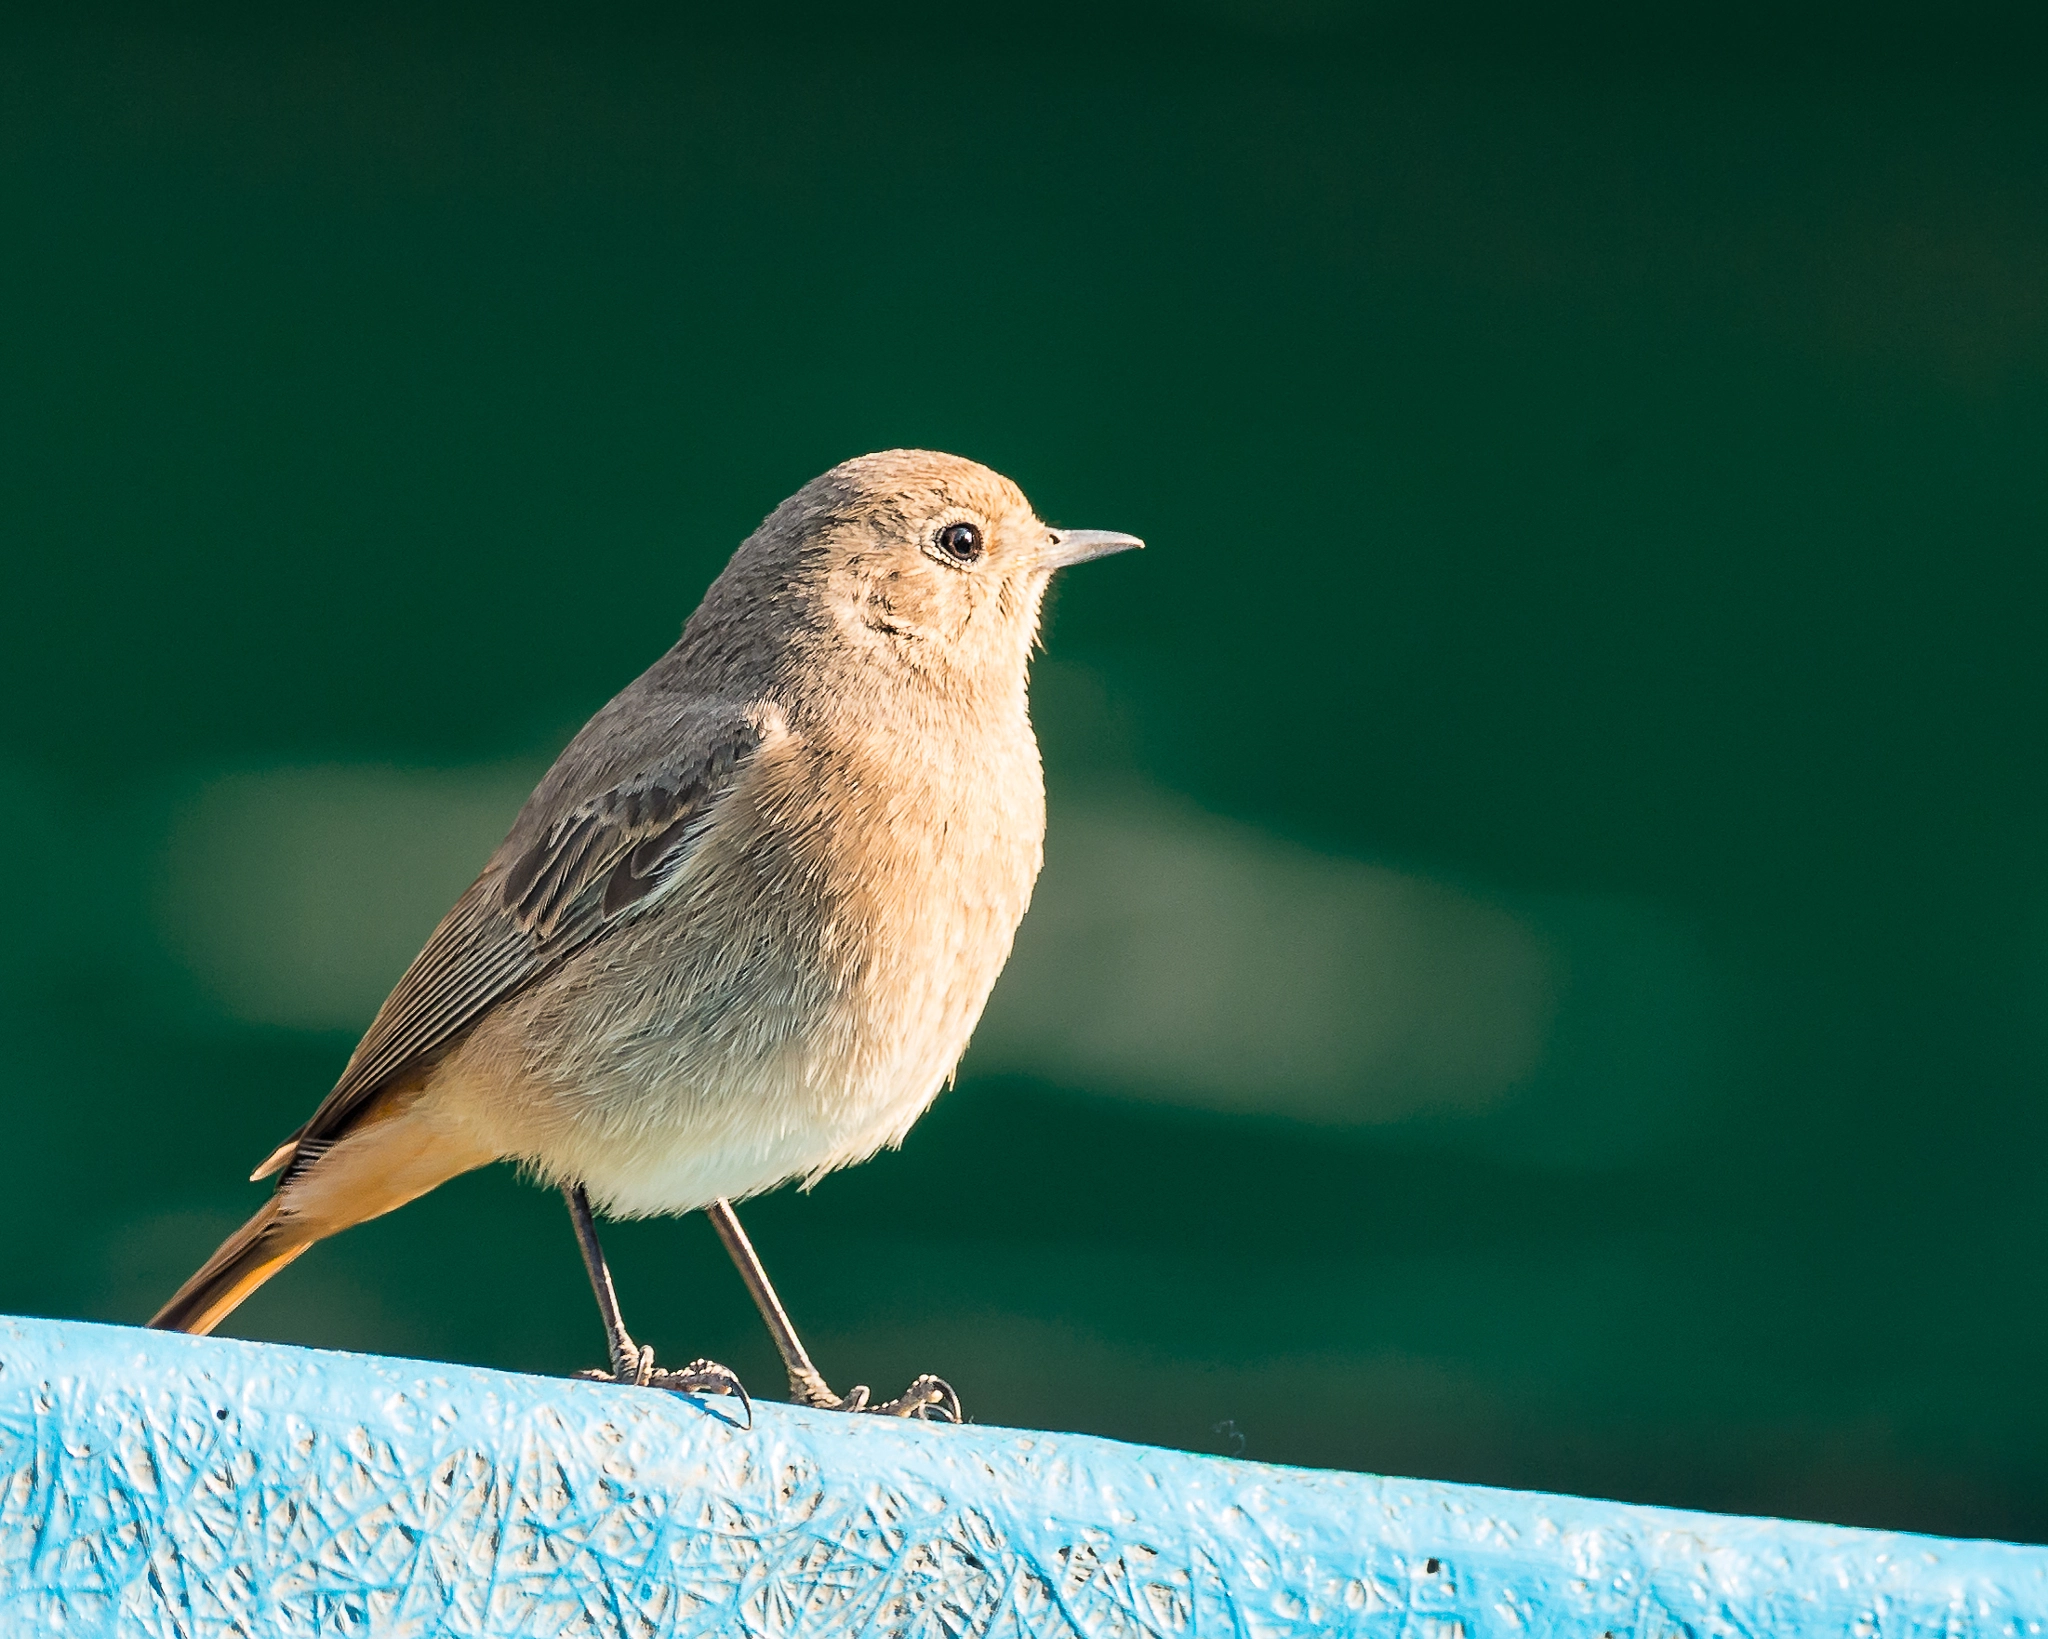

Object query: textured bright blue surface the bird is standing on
[0,1319,2048,1639]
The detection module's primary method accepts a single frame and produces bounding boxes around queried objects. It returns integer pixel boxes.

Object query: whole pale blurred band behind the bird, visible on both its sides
[144,762,1718,1164]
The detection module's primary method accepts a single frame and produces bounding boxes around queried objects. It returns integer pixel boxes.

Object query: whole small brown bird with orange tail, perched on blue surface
[150,451,1141,1420]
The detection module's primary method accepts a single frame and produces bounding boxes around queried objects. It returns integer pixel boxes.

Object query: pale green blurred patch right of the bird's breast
[973,793,1561,1125]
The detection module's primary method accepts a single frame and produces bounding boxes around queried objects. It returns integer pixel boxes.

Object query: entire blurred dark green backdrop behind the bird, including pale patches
[0,0,2048,1539]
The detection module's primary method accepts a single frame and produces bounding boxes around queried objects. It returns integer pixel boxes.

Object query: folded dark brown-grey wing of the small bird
[252,701,764,1178]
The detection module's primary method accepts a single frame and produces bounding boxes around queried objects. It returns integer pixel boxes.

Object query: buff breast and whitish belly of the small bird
[471,708,1044,1213]
